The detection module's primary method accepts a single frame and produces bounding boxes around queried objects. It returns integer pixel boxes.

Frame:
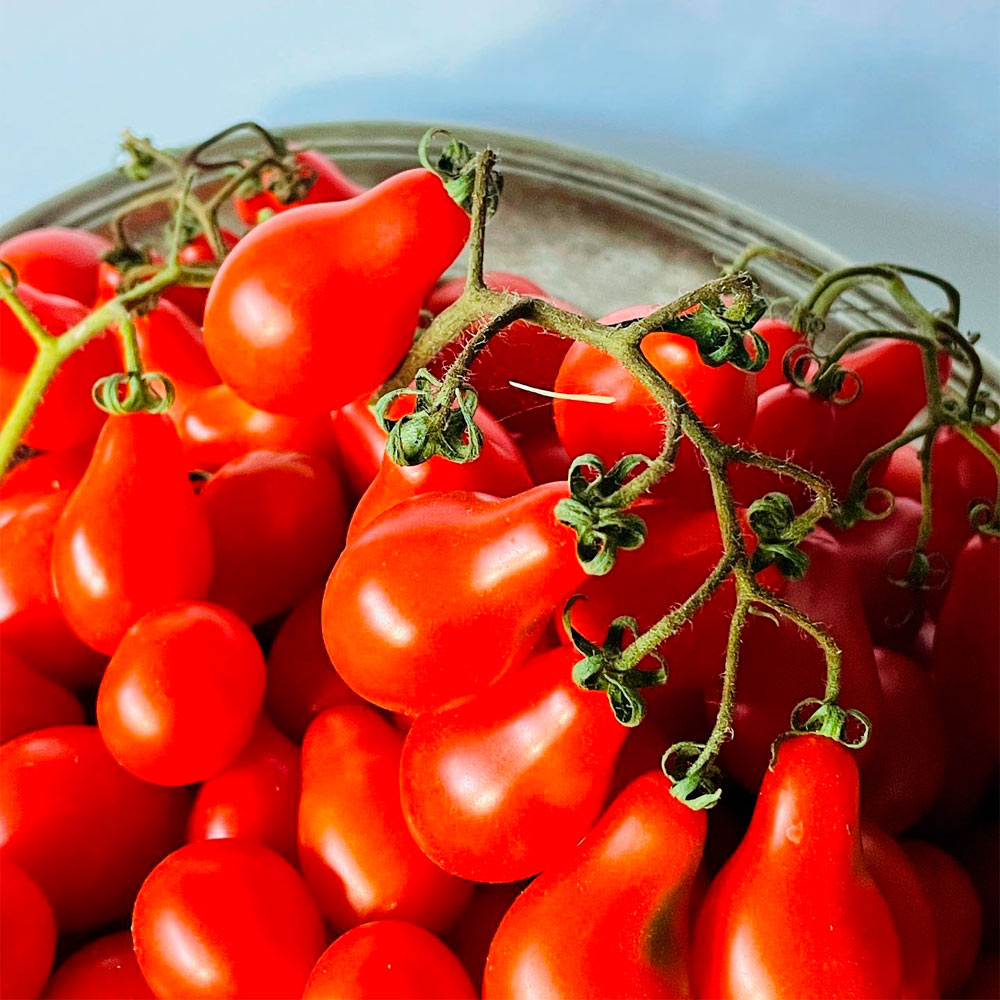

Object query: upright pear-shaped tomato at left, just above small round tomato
[52,413,212,653]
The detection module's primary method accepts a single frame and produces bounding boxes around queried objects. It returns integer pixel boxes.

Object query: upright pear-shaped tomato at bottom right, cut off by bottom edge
[692,736,902,1000]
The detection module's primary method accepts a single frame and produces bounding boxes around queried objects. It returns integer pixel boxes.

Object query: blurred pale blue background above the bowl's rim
[0,0,1000,350]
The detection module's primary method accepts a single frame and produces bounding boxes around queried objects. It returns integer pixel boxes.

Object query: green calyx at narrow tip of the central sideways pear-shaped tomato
[555,455,649,576]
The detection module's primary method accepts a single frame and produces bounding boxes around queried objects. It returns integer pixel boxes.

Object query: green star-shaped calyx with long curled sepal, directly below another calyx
[563,596,667,728]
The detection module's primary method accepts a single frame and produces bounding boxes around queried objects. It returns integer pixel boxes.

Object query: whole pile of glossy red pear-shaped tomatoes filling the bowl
[0,141,1000,1000]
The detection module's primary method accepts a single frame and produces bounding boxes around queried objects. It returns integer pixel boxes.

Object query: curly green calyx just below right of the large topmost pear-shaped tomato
[375,368,483,465]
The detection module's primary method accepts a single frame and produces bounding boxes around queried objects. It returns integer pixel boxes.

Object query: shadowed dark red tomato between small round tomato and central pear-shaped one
[264,587,361,743]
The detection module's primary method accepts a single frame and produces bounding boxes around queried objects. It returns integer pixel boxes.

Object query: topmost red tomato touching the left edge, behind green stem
[0,226,111,302]
